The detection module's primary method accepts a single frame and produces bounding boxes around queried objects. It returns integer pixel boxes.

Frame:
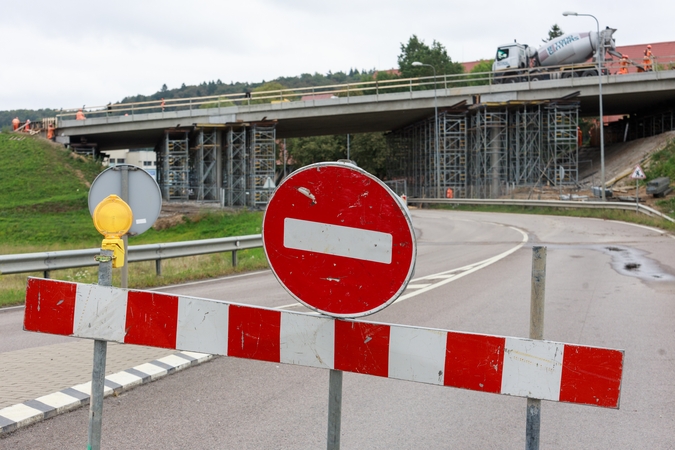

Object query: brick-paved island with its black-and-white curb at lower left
[0,339,211,435]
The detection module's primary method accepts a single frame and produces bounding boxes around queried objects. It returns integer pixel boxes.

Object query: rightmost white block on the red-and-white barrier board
[502,337,565,402]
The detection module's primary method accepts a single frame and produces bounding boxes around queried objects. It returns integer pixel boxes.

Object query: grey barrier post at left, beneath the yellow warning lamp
[87,250,113,450]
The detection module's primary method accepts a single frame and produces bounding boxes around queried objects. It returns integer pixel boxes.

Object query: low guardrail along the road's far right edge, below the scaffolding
[408,198,675,223]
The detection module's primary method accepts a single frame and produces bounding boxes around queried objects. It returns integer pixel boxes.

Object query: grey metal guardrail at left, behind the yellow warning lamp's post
[0,234,262,278]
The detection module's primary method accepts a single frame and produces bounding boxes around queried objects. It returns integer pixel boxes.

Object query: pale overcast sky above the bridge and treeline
[0,0,675,110]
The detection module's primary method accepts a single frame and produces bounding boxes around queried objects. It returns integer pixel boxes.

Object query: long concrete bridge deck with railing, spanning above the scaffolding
[57,70,675,151]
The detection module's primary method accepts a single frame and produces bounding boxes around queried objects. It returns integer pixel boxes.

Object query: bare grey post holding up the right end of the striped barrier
[525,246,546,450]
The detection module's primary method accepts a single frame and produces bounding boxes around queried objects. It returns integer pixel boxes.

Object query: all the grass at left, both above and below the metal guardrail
[0,133,267,307]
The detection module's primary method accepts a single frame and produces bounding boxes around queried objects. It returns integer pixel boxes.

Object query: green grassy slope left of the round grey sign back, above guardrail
[0,133,101,248]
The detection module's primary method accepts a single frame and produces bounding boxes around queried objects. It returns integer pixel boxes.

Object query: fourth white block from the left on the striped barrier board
[389,326,447,385]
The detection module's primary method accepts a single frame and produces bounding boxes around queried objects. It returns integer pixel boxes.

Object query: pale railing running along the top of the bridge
[57,55,675,120]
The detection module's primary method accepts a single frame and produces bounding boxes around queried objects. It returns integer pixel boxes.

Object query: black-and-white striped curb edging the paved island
[0,352,214,436]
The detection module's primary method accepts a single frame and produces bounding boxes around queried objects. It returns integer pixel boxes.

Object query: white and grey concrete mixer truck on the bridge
[492,28,621,83]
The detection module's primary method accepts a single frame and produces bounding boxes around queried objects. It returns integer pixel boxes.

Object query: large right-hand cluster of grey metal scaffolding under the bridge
[387,100,579,198]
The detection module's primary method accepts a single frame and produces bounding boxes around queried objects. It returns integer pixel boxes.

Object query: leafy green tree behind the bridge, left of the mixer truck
[398,34,464,78]
